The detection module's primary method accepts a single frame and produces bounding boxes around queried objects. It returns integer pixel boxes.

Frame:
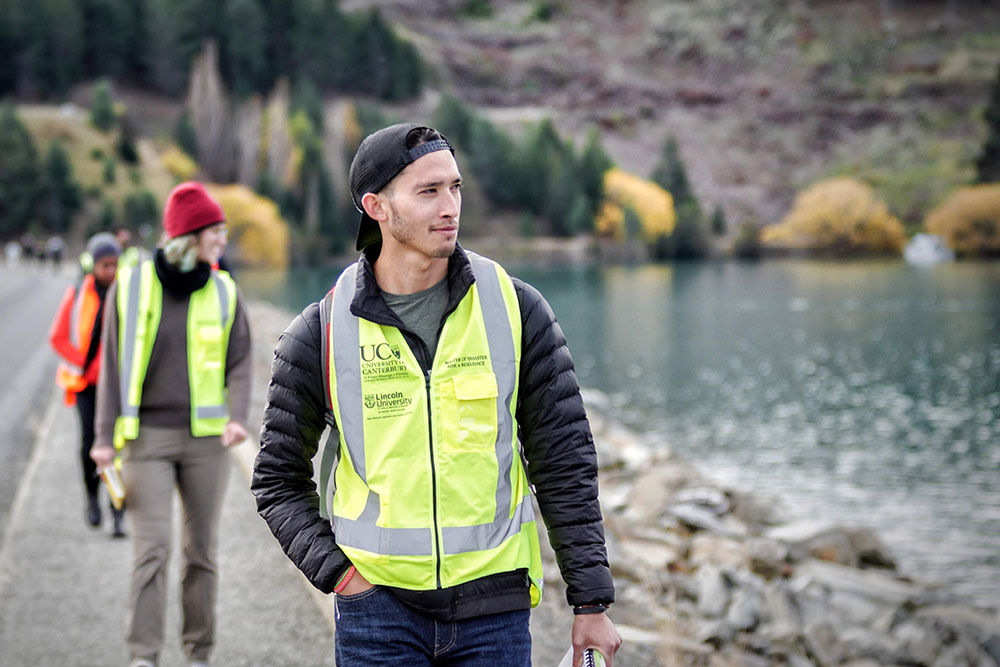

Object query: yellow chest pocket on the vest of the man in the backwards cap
[439,373,498,452]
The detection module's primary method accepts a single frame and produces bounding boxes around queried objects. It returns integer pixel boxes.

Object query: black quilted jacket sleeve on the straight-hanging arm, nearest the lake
[514,279,615,605]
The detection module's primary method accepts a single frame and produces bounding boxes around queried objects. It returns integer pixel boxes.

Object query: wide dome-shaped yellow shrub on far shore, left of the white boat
[761,178,906,253]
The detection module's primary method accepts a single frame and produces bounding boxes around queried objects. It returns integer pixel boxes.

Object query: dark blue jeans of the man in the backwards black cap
[334,586,531,667]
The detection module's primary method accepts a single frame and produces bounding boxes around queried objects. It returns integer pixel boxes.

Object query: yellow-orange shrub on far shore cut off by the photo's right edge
[924,183,1000,257]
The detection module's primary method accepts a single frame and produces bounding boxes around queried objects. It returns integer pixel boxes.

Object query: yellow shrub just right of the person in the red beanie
[206,185,288,269]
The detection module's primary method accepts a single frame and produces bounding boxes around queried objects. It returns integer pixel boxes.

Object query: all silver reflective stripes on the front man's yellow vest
[331,253,535,555]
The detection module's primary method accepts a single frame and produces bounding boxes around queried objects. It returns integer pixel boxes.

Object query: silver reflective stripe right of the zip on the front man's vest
[441,252,534,554]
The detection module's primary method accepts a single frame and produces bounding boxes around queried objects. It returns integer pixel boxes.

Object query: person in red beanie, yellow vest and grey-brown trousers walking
[91,182,251,667]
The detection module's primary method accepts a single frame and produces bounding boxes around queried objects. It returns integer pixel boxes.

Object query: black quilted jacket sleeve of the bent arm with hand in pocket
[250,303,350,593]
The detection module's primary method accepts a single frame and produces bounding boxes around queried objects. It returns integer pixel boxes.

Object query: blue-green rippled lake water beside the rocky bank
[238,260,1000,607]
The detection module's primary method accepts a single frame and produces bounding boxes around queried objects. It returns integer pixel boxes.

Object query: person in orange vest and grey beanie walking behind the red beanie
[49,232,125,537]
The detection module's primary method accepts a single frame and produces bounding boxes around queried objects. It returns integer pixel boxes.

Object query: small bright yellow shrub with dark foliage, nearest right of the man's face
[594,167,677,241]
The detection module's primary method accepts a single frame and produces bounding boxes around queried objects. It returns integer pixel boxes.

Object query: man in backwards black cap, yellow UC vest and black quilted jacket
[252,124,621,667]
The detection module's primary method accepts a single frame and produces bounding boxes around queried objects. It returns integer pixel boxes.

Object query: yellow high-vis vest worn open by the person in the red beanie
[114,260,236,449]
